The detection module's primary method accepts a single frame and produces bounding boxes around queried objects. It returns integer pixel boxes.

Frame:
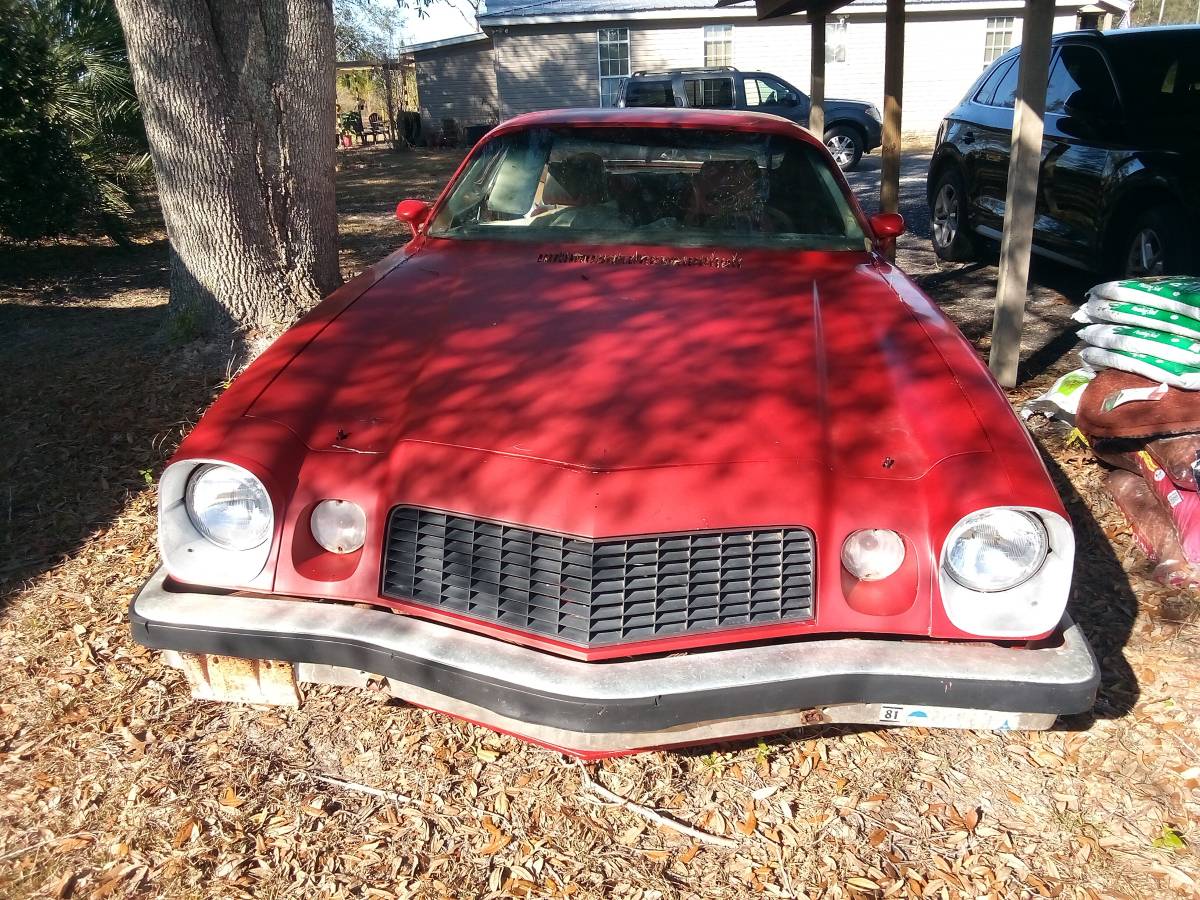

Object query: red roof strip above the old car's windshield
[492,107,821,146]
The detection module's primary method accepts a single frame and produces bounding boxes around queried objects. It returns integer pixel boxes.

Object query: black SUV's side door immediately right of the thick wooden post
[1034,43,1122,262]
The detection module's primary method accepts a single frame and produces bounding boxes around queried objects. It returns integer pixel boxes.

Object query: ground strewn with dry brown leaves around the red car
[0,150,1200,900]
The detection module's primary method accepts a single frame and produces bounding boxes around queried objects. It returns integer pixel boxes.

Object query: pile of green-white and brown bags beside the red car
[1031,277,1200,587]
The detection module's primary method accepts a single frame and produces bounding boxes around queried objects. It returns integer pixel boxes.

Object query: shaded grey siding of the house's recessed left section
[415,41,500,133]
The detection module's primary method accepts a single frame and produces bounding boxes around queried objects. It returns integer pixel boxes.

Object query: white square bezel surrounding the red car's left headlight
[158,457,278,587]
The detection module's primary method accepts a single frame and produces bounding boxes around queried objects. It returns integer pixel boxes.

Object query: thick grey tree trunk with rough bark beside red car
[116,0,341,334]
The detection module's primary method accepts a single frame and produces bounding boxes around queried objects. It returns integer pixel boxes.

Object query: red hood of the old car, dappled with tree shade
[244,240,989,479]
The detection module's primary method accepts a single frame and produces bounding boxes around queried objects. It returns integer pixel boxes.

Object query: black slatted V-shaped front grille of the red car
[383,506,814,647]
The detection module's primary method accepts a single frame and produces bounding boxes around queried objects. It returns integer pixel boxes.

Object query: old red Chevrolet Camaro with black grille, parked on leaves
[131,109,1097,757]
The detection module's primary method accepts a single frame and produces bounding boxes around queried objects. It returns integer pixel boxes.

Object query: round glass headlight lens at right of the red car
[946,509,1050,593]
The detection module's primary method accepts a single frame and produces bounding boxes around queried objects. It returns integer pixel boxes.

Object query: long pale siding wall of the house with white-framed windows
[493,7,1099,133]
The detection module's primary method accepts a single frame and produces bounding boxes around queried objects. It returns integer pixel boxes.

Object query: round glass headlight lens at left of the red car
[185,463,272,551]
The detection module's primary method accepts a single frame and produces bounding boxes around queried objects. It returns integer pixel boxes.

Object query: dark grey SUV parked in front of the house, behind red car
[617,67,880,170]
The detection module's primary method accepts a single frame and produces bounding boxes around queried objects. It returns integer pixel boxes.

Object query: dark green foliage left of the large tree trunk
[0,0,151,241]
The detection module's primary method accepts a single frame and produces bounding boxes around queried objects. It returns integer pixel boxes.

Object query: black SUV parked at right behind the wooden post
[926,26,1200,276]
